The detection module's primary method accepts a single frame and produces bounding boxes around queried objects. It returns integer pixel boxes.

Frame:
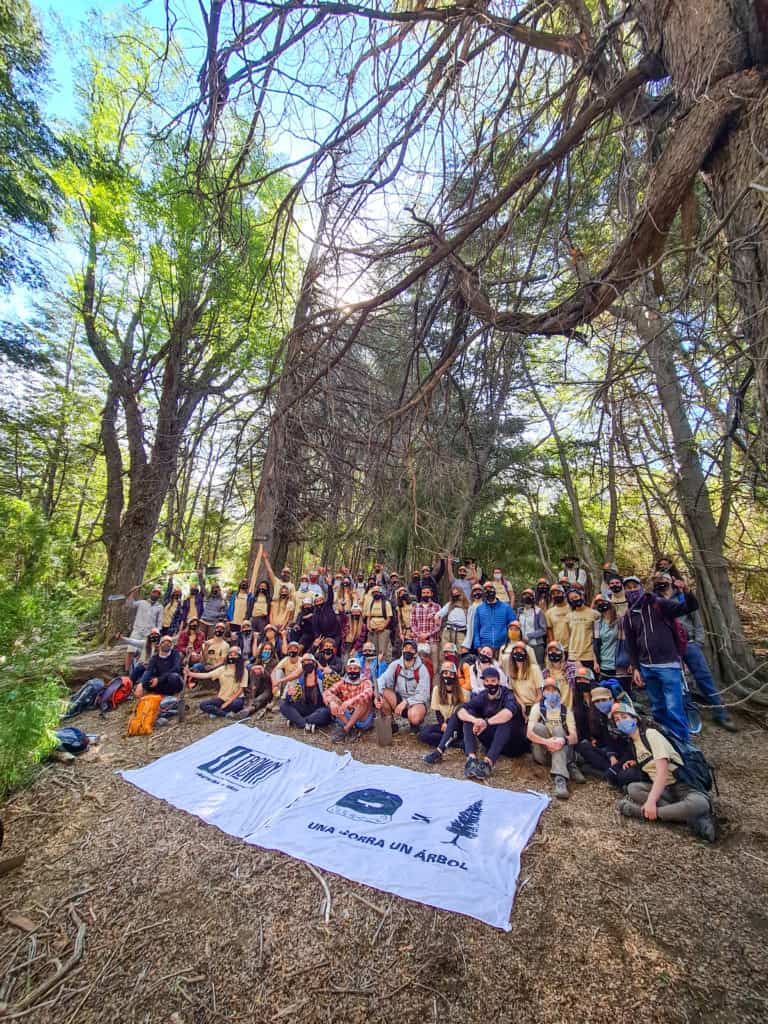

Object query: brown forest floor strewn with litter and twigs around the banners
[0,701,768,1024]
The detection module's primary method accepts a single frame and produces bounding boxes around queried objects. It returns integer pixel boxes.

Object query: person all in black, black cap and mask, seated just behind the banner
[423,665,527,779]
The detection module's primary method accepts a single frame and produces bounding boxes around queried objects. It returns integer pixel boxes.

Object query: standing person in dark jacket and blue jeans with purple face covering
[622,575,698,740]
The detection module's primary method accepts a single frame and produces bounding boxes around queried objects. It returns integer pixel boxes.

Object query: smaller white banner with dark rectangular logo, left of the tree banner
[120,725,351,838]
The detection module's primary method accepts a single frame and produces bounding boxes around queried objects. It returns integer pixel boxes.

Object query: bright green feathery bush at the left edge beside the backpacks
[0,498,74,799]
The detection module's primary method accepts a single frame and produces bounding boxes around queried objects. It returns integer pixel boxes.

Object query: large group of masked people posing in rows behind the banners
[120,554,736,840]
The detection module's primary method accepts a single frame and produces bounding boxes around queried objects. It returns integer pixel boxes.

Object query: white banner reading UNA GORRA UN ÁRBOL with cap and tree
[252,761,549,930]
